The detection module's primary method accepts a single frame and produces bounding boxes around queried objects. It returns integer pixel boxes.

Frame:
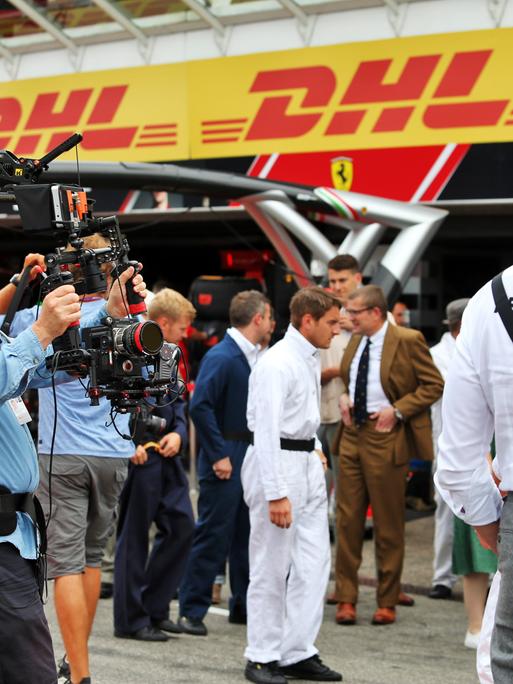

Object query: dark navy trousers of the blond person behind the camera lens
[114,450,194,633]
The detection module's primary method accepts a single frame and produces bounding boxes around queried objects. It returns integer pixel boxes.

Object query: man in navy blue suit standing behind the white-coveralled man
[179,290,271,636]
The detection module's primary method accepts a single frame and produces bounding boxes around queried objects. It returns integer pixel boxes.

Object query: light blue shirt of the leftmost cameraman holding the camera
[0,307,119,559]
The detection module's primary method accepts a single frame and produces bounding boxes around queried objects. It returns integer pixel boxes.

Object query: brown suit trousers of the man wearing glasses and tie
[335,420,408,608]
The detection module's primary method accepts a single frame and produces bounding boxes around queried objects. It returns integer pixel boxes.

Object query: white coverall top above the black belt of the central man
[247,325,321,501]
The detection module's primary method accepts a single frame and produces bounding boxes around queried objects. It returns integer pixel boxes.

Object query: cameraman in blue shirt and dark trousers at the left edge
[0,254,145,684]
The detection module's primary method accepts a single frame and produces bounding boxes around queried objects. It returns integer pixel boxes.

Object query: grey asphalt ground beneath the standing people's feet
[47,517,478,684]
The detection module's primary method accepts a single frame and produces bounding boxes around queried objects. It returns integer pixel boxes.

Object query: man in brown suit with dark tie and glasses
[334,285,443,625]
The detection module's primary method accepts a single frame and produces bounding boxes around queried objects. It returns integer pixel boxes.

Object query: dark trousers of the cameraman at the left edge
[0,542,57,684]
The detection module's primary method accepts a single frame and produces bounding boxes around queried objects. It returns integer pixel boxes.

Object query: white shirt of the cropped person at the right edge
[435,266,513,525]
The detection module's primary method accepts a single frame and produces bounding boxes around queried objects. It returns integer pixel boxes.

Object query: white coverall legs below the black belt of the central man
[241,447,330,665]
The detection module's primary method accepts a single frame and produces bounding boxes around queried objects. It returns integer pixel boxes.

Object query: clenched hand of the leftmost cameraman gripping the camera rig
[32,285,80,349]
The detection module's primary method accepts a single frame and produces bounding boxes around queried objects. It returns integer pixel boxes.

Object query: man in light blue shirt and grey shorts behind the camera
[0,248,146,684]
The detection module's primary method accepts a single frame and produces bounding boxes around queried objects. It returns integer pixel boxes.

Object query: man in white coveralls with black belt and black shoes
[242,287,342,684]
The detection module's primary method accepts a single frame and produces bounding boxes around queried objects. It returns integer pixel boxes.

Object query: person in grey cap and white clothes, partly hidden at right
[429,298,469,599]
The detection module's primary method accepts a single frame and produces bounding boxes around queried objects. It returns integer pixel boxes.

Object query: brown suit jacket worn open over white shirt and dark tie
[333,325,444,465]
